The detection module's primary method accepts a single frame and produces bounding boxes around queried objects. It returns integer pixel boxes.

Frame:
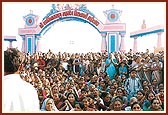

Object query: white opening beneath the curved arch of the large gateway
[40,21,101,53]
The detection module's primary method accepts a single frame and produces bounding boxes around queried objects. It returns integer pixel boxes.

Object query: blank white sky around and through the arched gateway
[2,2,166,53]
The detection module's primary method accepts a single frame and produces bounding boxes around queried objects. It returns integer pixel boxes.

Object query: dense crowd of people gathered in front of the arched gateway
[3,49,165,111]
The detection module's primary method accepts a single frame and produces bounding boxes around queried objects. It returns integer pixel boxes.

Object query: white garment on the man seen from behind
[2,74,40,112]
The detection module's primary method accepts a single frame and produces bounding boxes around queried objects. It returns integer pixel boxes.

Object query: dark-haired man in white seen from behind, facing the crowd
[2,48,40,112]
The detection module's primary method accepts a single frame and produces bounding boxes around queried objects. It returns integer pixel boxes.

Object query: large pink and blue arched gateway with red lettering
[18,4,126,54]
